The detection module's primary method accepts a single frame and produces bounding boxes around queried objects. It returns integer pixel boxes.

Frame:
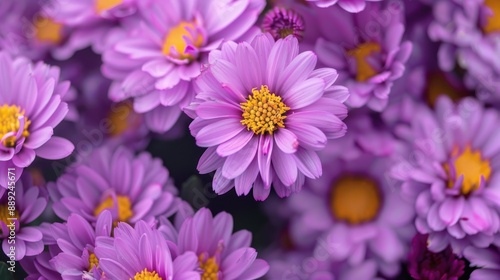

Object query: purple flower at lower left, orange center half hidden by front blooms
[48,147,178,224]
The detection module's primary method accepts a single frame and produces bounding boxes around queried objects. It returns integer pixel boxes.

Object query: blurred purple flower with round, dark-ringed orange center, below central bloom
[287,143,415,279]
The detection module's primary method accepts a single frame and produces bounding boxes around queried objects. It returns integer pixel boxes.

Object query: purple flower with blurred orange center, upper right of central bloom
[314,2,412,111]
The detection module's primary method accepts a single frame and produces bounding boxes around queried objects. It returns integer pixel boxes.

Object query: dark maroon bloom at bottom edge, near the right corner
[408,234,465,280]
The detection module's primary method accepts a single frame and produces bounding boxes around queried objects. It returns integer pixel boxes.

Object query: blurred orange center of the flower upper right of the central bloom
[347,42,381,82]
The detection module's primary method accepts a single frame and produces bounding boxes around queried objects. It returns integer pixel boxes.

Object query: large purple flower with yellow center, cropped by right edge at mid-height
[392,97,500,254]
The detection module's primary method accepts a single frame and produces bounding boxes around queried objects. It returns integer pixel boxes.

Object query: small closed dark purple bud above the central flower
[262,7,304,40]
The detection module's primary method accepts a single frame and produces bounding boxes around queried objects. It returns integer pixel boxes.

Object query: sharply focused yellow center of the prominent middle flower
[240,85,290,135]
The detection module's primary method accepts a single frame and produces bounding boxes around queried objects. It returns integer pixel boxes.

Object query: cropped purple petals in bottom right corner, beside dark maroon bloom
[464,240,500,280]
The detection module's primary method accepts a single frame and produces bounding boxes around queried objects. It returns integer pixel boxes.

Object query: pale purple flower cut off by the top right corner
[429,0,500,102]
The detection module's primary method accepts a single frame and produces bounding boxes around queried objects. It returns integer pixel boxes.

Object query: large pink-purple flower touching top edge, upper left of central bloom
[102,0,265,133]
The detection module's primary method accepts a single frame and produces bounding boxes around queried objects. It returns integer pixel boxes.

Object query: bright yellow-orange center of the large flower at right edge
[444,145,491,195]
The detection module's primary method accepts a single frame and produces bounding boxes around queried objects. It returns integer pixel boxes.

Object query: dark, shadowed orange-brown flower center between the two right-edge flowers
[426,72,467,107]
